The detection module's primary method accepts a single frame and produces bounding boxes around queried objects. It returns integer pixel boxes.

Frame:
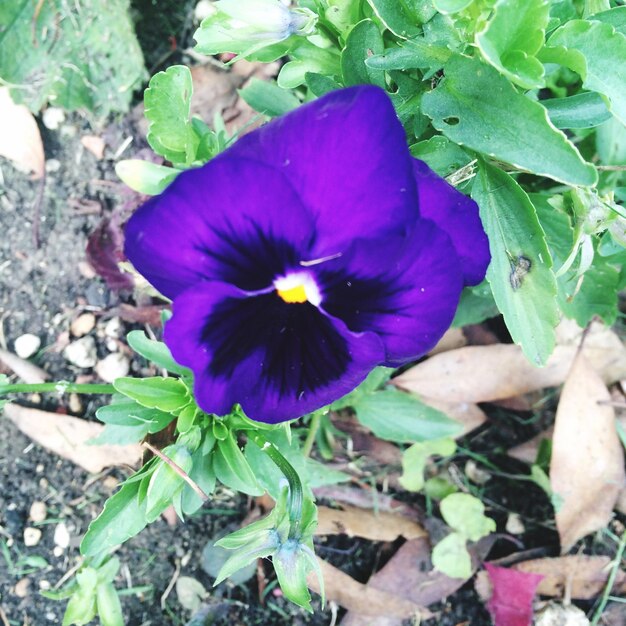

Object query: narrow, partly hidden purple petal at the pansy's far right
[413,159,491,285]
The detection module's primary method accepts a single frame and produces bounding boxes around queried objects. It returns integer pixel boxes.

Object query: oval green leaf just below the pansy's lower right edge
[354,388,463,443]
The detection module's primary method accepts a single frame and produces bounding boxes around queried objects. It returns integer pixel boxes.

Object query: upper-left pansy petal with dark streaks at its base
[125,156,315,298]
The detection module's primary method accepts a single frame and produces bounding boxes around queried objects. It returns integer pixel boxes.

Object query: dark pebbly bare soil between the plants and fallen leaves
[0,0,620,626]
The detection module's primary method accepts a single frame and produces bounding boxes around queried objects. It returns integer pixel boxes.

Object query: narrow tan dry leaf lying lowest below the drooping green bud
[307,559,431,624]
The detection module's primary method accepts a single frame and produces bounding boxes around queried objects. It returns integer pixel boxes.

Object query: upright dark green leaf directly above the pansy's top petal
[341,20,385,89]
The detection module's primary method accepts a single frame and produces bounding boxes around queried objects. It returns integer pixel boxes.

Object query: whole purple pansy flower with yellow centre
[126,86,489,422]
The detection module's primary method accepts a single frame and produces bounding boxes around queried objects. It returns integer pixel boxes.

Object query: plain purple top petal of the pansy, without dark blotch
[218,85,419,257]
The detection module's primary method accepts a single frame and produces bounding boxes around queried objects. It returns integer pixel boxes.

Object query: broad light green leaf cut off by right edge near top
[542,20,626,124]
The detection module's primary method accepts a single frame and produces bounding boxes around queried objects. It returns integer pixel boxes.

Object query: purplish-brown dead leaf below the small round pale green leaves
[341,524,494,626]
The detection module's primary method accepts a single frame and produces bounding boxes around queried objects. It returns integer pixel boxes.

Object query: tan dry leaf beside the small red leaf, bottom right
[512,554,626,600]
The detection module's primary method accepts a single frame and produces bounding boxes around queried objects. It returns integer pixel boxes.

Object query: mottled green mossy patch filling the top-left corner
[0,0,145,116]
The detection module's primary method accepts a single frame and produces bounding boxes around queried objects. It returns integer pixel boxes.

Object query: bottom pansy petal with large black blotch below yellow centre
[165,282,385,423]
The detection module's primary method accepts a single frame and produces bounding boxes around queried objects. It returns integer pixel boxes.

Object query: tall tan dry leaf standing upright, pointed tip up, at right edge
[550,352,626,552]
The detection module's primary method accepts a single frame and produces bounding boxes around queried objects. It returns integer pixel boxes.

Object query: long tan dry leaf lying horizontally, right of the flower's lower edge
[391,327,626,403]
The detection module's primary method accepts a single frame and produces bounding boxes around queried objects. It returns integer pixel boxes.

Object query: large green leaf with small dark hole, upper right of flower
[422,55,597,185]
